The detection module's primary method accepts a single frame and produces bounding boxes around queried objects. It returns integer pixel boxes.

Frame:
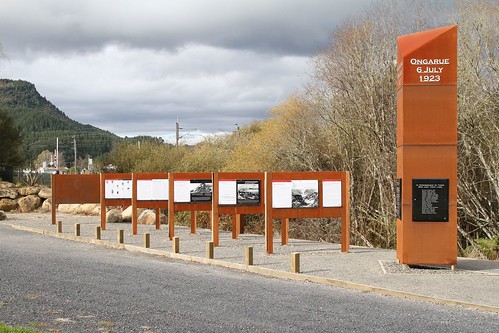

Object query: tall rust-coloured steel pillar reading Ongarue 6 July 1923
[397,26,457,265]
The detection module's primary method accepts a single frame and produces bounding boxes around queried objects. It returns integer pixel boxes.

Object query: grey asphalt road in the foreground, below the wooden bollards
[0,225,499,333]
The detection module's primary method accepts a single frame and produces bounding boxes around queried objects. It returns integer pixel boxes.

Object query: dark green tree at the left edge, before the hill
[0,111,25,181]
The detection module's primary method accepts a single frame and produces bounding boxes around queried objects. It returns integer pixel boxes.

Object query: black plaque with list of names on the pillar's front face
[412,179,449,222]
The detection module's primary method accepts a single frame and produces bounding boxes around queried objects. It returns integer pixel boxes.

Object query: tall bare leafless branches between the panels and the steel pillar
[307,1,456,247]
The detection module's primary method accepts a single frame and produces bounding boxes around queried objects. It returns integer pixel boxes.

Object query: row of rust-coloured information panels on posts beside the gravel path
[48,172,349,253]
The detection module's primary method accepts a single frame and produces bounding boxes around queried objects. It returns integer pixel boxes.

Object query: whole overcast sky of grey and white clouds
[0,0,370,143]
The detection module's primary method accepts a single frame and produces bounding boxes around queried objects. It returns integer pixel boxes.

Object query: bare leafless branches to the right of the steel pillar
[456,2,499,252]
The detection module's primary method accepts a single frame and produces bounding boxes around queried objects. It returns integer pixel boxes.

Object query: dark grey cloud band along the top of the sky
[0,0,368,55]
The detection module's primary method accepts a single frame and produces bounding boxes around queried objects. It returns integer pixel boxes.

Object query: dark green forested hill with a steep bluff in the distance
[0,79,120,165]
